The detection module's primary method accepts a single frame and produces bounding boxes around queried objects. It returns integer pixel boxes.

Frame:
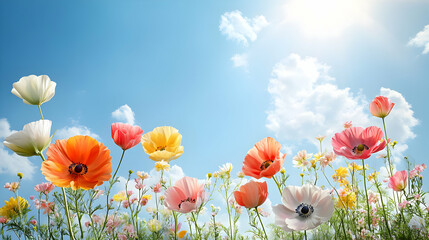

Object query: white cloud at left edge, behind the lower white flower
[0,118,35,181]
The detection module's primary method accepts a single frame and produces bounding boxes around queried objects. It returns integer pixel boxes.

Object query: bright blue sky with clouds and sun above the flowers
[0,0,429,231]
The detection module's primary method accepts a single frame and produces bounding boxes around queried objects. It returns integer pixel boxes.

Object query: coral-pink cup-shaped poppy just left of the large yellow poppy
[111,123,143,150]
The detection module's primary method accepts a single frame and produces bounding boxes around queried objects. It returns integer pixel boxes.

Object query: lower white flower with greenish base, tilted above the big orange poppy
[3,120,52,157]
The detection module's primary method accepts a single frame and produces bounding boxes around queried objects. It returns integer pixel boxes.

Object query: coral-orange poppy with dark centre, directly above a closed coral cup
[242,137,286,179]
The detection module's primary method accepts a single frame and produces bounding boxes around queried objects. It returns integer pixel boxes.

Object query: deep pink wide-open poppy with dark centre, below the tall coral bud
[332,126,386,159]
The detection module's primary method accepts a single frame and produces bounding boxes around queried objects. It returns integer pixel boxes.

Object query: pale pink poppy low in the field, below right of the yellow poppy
[164,177,204,213]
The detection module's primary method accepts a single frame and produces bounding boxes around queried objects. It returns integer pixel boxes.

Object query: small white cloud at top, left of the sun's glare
[219,10,268,46]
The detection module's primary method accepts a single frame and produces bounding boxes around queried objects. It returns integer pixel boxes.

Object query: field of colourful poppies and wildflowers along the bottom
[0,75,429,239]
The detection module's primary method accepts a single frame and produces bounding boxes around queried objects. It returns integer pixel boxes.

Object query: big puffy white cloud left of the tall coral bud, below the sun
[266,54,370,148]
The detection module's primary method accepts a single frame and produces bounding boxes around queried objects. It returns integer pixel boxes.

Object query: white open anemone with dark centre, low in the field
[273,184,334,232]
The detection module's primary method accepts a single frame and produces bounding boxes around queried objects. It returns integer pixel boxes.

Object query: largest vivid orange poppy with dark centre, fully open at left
[41,136,112,190]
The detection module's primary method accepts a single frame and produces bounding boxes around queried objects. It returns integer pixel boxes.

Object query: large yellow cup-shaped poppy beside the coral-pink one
[142,126,183,162]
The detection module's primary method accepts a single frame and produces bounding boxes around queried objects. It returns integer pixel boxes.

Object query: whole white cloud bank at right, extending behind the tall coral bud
[266,54,418,163]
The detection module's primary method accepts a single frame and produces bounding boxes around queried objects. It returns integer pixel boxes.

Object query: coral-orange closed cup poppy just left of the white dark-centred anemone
[234,181,268,208]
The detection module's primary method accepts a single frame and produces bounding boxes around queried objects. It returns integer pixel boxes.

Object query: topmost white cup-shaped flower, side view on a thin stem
[12,75,57,105]
